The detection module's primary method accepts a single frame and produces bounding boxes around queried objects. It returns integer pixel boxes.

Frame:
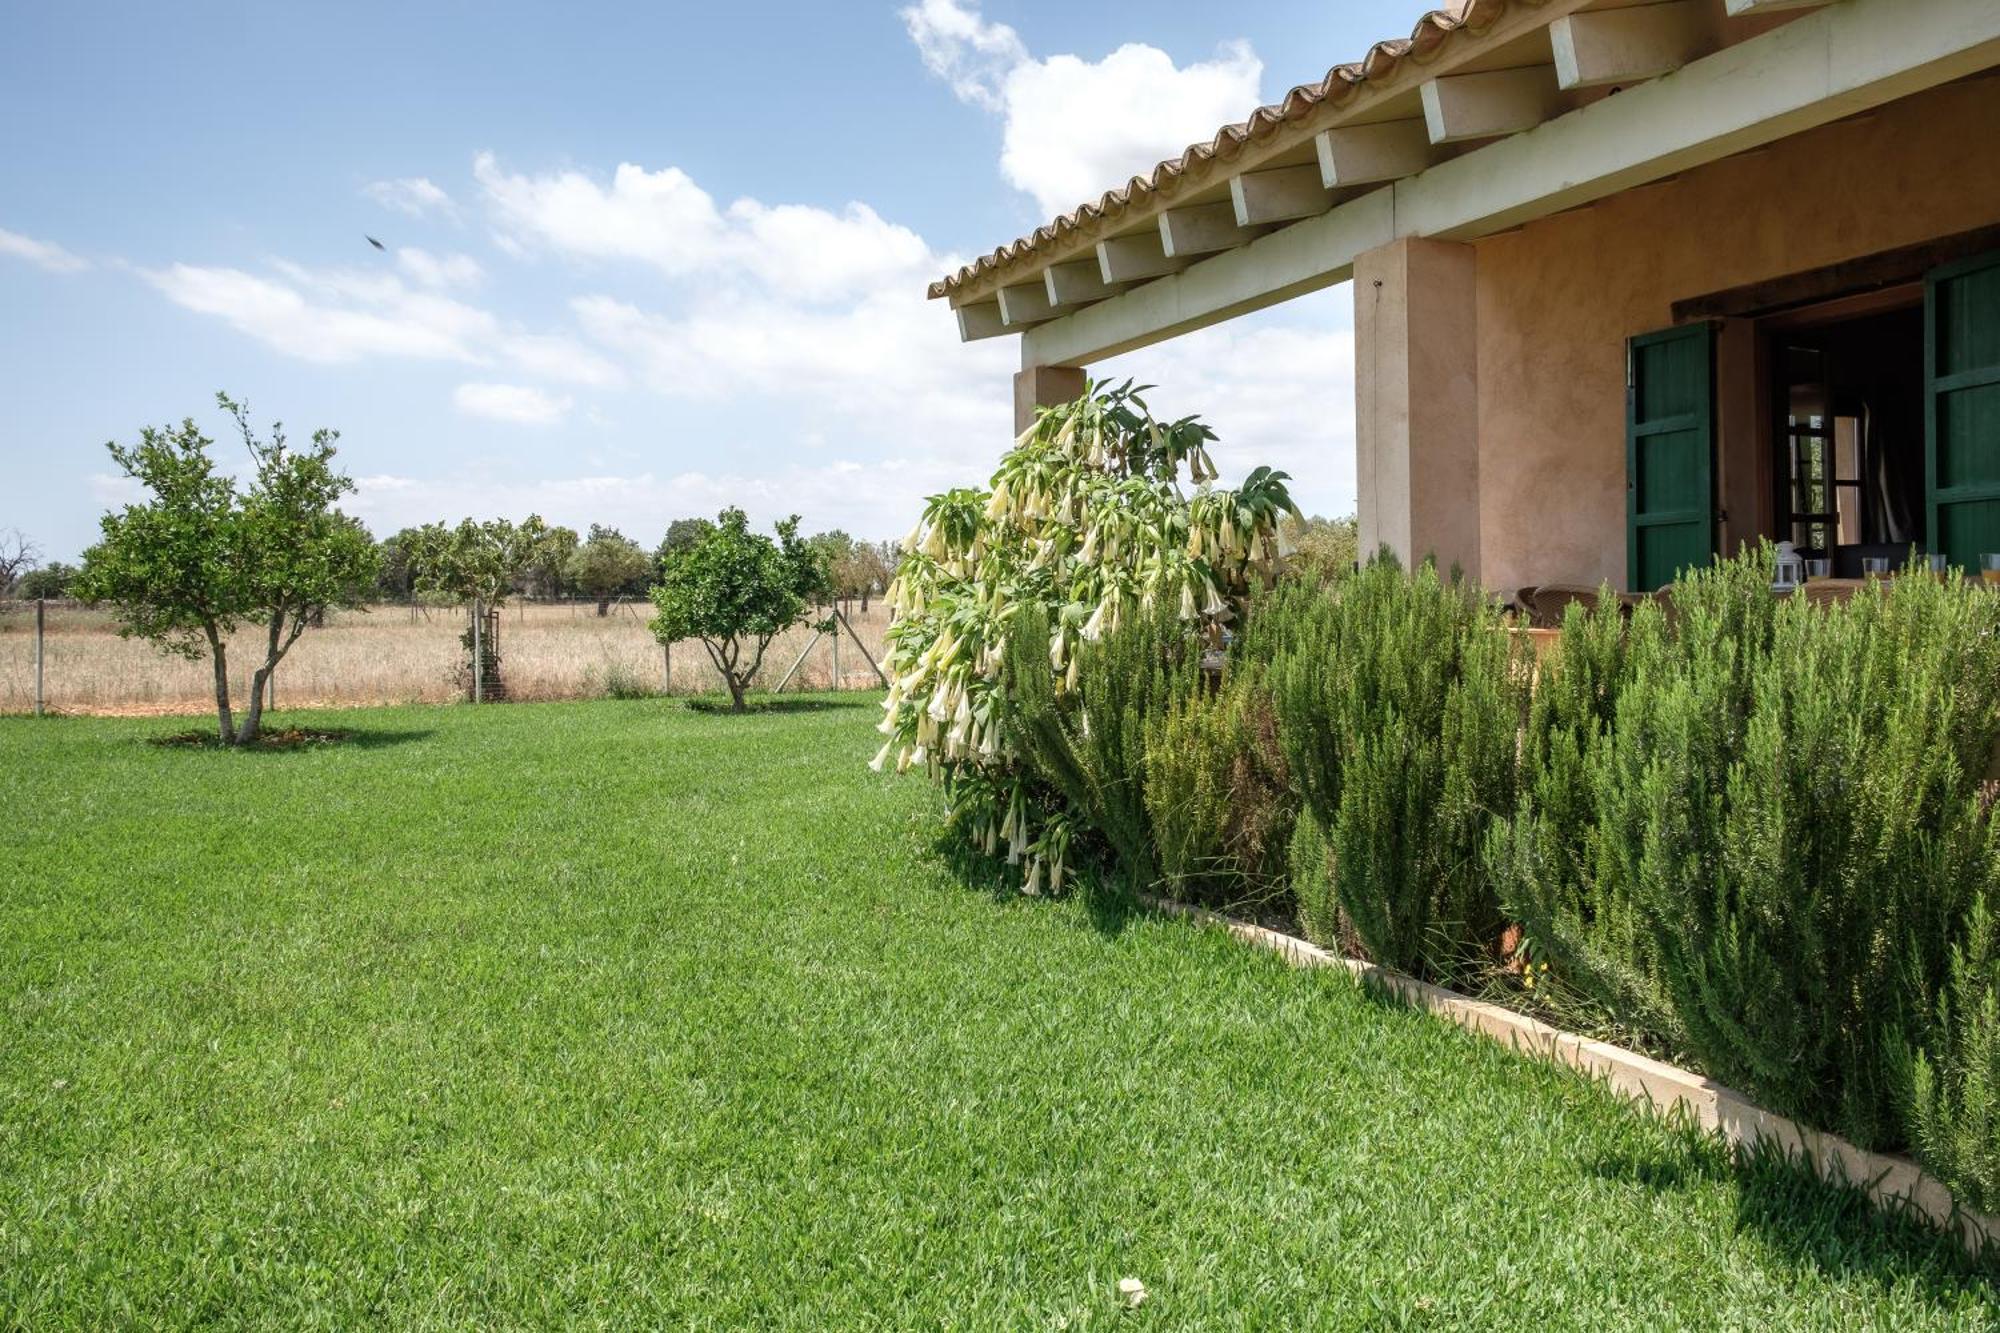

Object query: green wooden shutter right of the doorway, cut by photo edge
[1924,250,2000,568]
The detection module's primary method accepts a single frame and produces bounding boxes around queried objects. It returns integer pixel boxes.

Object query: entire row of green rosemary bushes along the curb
[924,528,2000,1207]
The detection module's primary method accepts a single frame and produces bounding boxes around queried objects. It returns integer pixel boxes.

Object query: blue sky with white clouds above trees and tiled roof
[0,0,1416,558]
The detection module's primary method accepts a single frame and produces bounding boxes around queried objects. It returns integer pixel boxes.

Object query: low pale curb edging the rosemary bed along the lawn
[1140,895,2000,1255]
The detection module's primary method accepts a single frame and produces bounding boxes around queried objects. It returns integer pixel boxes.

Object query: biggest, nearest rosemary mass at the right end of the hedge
[1486,556,2000,1201]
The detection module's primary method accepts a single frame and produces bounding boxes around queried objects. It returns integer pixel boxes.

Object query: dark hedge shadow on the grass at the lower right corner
[1590,1125,2000,1288]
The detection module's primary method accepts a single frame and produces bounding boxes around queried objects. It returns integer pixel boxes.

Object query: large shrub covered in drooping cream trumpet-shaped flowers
[874,380,1296,893]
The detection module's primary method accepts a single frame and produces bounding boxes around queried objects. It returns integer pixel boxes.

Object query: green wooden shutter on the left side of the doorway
[1626,324,1716,592]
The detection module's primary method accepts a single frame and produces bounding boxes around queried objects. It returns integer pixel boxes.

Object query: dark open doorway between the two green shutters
[1764,294,1926,578]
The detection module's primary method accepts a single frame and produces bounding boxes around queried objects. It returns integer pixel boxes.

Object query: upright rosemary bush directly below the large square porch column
[1250,556,1528,981]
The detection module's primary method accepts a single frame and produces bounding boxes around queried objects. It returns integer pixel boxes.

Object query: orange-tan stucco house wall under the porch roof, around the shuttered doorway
[1474,76,2000,592]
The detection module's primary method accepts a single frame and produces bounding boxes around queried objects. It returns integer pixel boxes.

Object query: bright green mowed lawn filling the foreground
[0,697,2000,1331]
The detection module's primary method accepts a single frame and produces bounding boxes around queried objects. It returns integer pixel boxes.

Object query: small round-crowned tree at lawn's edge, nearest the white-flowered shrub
[650,508,826,713]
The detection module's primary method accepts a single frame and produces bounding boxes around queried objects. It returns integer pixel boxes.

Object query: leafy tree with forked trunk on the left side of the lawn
[74,394,376,745]
